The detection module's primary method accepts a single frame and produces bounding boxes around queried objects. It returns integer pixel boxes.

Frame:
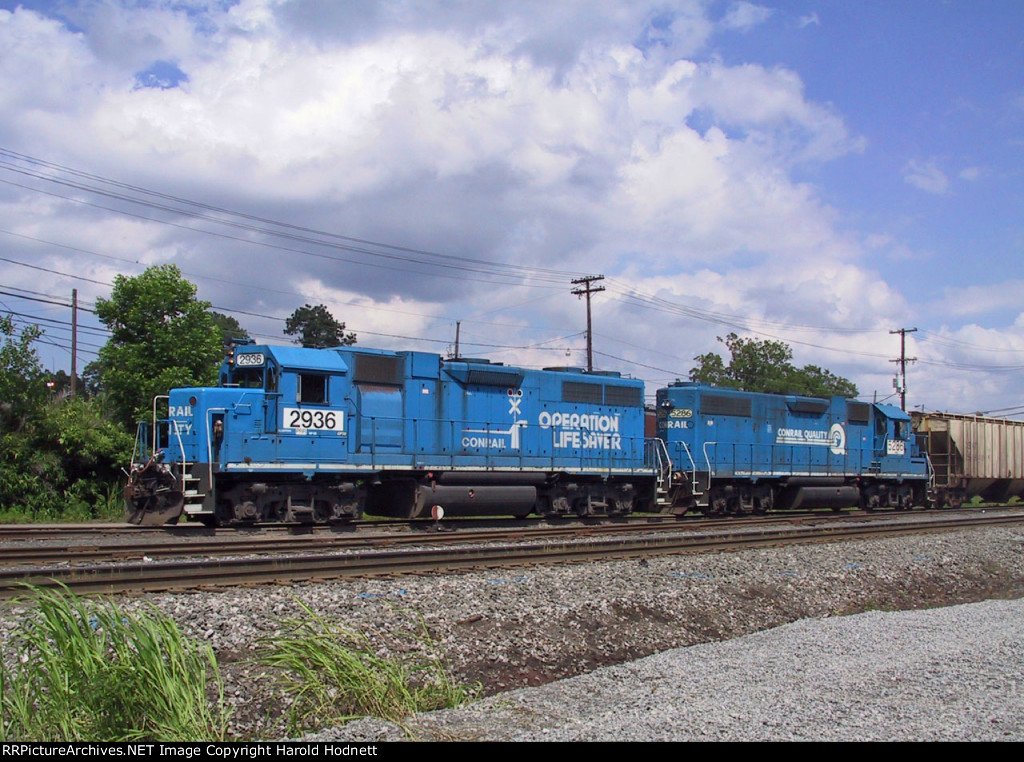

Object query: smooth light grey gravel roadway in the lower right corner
[325,600,1024,742]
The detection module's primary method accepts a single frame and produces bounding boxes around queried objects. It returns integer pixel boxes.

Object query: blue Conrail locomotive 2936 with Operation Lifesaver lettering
[126,344,654,525]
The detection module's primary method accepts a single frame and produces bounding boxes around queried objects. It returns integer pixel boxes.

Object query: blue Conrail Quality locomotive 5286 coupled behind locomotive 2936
[656,382,929,515]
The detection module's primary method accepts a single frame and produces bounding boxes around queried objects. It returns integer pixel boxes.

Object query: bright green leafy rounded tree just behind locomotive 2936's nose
[96,264,222,424]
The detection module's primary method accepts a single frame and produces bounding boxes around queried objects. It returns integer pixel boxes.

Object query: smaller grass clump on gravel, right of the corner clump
[258,602,478,733]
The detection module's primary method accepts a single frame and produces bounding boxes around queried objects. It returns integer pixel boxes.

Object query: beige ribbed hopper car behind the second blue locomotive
[911,412,1024,508]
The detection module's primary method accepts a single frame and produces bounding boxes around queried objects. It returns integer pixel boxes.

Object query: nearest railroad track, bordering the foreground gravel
[0,511,1024,597]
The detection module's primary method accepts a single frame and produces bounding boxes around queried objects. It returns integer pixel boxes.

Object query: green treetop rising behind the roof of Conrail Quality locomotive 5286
[690,333,857,397]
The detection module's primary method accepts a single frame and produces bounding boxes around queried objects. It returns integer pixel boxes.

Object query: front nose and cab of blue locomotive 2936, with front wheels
[126,344,362,525]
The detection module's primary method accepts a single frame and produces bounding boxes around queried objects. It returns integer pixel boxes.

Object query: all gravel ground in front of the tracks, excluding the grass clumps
[0,520,1024,740]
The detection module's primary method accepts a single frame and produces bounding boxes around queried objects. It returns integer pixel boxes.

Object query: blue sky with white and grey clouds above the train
[0,0,1024,412]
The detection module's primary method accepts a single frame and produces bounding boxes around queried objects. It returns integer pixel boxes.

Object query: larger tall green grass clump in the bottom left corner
[0,588,228,742]
